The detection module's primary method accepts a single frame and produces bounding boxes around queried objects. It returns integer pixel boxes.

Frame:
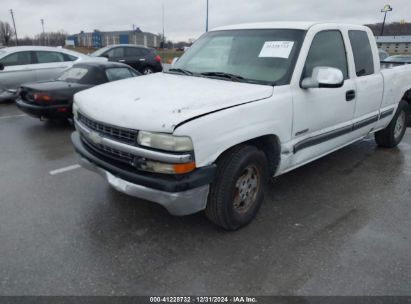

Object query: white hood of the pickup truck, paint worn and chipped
[74,73,273,133]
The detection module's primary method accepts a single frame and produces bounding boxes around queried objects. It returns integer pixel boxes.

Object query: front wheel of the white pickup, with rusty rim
[205,146,268,231]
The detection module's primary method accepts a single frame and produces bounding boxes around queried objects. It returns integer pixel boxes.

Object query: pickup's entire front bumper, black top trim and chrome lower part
[71,132,216,216]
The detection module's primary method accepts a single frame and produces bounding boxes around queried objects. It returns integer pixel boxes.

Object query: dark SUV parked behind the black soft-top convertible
[90,44,163,75]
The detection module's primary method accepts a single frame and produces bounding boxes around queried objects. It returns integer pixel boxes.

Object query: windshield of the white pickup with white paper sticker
[171,29,305,85]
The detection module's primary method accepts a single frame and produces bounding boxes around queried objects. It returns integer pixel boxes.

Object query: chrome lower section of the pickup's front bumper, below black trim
[79,156,209,216]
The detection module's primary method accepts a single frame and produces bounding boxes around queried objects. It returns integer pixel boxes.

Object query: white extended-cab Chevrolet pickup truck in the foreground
[72,22,411,230]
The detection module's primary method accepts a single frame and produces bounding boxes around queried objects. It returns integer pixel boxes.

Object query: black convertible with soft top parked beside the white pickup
[16,62,141,119]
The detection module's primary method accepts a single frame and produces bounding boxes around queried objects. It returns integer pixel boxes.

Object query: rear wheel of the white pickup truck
[374,100,410,148]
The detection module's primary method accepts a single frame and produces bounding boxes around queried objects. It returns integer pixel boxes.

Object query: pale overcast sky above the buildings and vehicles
[0,0,411,41]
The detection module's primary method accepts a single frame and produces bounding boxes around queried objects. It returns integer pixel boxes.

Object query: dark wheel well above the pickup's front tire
[217,135,281,175]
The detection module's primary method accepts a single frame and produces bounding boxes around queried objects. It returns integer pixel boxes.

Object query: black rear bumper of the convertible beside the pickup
[16,98,72,118]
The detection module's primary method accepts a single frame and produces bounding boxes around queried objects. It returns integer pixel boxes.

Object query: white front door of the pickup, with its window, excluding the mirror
[292,29,356,166]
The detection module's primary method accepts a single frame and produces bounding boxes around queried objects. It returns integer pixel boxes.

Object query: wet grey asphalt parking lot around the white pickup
[0,104,411,295]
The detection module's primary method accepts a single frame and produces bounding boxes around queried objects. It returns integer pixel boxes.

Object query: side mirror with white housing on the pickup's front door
[301,67,344,89]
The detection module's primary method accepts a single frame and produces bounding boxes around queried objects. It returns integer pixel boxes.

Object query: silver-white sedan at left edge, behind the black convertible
[0,46,107,101]
